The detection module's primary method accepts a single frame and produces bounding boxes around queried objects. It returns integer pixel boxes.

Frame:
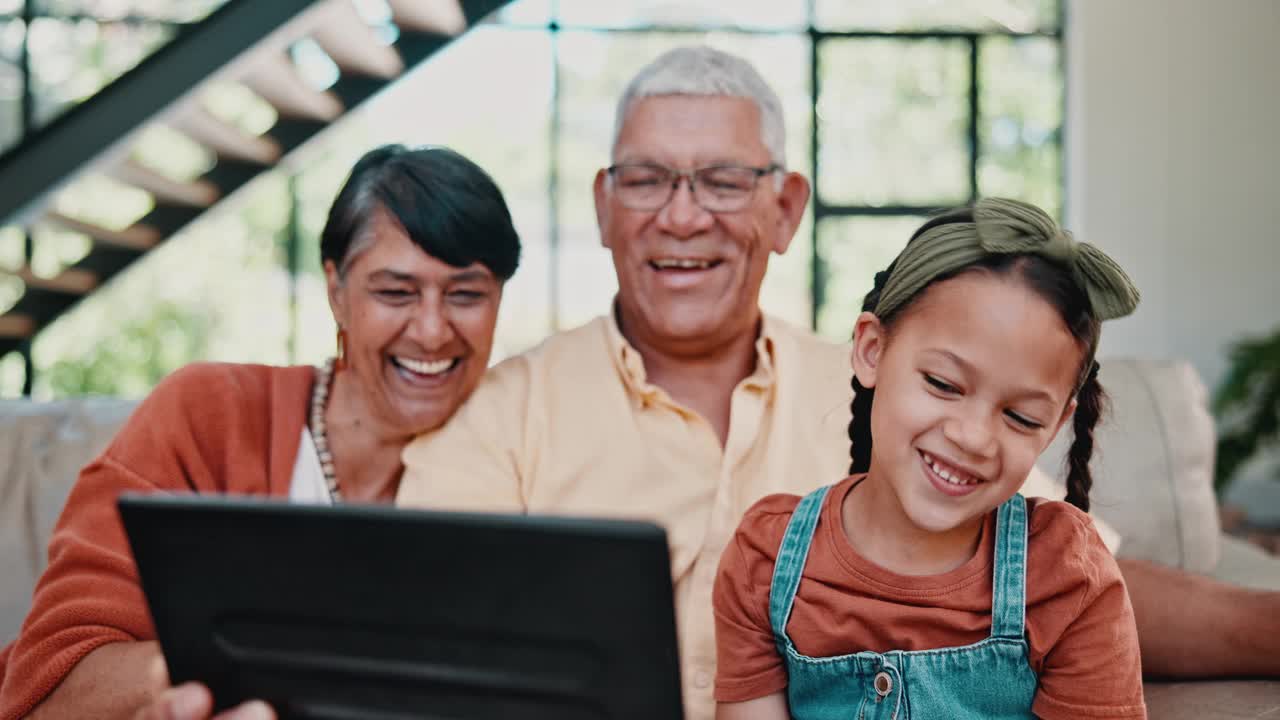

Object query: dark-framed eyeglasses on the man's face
[605,164,782,213]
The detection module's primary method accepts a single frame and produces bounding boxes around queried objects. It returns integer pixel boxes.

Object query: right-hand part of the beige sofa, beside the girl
[1038,359,1280,720]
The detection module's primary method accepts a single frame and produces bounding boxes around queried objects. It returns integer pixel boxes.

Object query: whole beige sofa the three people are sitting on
[0,359,1280,719]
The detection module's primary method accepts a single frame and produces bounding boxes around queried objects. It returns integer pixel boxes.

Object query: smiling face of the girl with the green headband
[852,270,1084,533]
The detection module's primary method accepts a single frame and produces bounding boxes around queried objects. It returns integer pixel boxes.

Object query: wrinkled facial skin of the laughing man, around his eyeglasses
[595,95,809,355]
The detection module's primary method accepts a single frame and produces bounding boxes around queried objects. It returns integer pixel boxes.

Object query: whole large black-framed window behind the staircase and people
[0,0,1064,397]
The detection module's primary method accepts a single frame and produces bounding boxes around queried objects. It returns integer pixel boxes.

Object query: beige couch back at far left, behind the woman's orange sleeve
[0,398,134,638]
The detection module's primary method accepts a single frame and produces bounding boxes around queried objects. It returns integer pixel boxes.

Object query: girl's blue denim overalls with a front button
[769,487,1037,720]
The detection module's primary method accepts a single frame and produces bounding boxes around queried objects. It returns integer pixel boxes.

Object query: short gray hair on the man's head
[613,46,787,168]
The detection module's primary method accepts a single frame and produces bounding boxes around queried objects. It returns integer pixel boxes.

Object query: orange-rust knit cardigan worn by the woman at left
[0,363,315,720]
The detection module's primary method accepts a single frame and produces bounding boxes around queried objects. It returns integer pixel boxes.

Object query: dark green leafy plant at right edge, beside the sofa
[1213,328,1280,492]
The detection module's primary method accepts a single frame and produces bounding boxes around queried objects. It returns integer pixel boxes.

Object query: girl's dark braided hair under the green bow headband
[849,208,1106,511]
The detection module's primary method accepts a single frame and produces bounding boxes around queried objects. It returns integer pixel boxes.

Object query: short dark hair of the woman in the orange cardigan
[320,145,520,281]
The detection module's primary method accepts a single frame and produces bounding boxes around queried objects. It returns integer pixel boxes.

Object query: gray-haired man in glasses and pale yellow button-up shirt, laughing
[398,47,1280,719]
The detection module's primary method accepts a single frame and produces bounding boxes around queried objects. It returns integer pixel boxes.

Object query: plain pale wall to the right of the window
[1065,0,1280,386]
